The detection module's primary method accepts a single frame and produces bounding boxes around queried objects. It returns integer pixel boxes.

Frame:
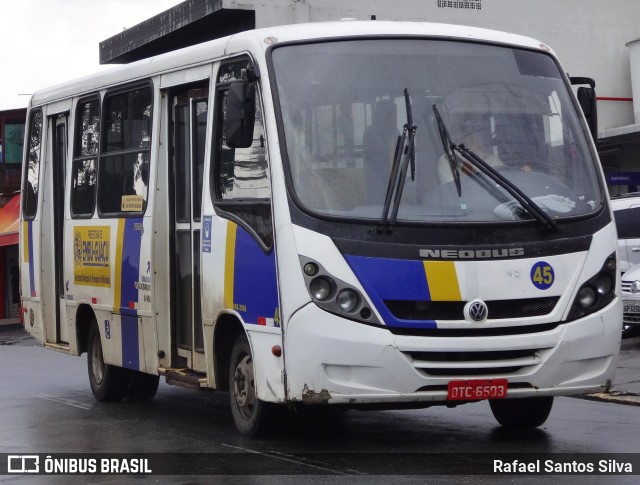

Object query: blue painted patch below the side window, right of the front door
[233,226,278,323]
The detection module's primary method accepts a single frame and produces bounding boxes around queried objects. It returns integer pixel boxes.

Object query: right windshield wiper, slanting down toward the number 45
[433,104,558,231]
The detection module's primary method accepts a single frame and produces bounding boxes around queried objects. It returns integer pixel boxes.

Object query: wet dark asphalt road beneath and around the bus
[0,333,640,484]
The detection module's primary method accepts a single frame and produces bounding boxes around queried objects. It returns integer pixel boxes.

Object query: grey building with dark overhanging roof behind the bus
[100,0,640,195]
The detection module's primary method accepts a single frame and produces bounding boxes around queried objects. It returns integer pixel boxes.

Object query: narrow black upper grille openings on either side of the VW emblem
[384,296,559,320]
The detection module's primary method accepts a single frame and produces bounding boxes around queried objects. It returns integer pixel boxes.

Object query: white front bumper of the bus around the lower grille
[285,299,622,405]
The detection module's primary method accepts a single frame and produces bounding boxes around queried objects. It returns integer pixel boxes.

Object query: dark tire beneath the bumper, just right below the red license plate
[489,396,553,428]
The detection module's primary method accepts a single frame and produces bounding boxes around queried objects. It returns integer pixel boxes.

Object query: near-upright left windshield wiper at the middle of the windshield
[378,88,418,232]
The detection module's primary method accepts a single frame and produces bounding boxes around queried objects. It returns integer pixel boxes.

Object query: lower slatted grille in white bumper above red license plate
[403,349,546,377]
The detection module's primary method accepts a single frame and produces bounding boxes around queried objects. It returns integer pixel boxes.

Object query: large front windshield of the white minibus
[272,38,603,223]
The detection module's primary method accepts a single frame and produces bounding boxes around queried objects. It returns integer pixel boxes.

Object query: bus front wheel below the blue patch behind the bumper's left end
[229,334,276,438]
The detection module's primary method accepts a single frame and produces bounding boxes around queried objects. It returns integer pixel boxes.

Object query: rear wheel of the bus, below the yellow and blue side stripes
[87,318,131,402]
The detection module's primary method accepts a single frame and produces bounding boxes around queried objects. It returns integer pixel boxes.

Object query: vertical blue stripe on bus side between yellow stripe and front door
[120,217,142,370]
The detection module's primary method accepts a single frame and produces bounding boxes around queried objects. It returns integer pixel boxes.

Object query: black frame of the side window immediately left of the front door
[94,79,155,219]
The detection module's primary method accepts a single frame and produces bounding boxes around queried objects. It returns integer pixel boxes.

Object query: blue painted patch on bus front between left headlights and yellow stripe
[345,255,437,328]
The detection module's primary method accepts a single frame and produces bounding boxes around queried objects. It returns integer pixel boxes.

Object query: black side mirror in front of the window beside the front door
[224,81,256,148]
